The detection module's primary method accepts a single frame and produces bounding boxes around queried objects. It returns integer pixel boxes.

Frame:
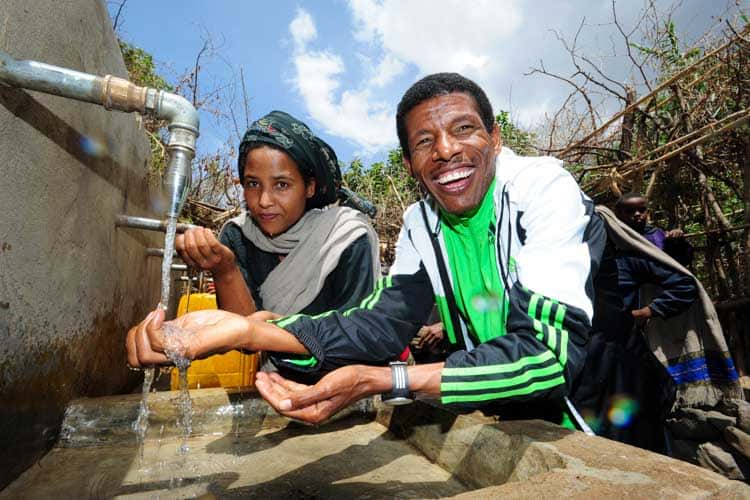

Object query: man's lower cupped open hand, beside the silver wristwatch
[255,365,382,424]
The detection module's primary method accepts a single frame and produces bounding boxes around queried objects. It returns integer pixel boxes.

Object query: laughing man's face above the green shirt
[405,92,501,214]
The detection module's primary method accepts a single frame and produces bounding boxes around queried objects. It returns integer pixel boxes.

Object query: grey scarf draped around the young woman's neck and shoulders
[227,206,380,314]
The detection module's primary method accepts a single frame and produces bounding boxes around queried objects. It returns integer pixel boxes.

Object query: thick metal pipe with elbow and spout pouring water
[0,51,200,217]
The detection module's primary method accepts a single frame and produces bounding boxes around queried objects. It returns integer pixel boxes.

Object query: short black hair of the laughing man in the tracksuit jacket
[396,73,495,159]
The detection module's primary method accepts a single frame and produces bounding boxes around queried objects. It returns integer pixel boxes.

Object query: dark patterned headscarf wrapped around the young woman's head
[237,111,341,208]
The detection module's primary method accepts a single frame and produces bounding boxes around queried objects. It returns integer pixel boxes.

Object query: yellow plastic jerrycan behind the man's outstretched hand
[170,293,258,391]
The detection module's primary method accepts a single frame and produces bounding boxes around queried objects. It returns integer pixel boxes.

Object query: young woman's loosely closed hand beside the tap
[175,227,235,276]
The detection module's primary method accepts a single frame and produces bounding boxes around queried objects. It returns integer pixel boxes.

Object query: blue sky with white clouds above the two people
[107,0,747,167]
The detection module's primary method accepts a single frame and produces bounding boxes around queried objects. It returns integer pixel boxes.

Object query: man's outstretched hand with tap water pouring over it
[125,308,253,368]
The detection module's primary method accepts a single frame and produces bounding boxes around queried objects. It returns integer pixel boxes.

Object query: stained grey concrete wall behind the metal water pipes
[0,0,163,488]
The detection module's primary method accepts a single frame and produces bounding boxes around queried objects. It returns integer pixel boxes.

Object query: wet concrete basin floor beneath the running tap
[0,391,466,499]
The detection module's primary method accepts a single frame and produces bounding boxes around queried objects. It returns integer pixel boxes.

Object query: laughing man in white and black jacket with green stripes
[250,73,606,428]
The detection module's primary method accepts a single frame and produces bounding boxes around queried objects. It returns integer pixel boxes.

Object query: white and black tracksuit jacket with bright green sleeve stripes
[272,148,606,414]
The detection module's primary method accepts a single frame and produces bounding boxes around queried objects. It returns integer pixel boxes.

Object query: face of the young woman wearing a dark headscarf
[243,146,315,237]
